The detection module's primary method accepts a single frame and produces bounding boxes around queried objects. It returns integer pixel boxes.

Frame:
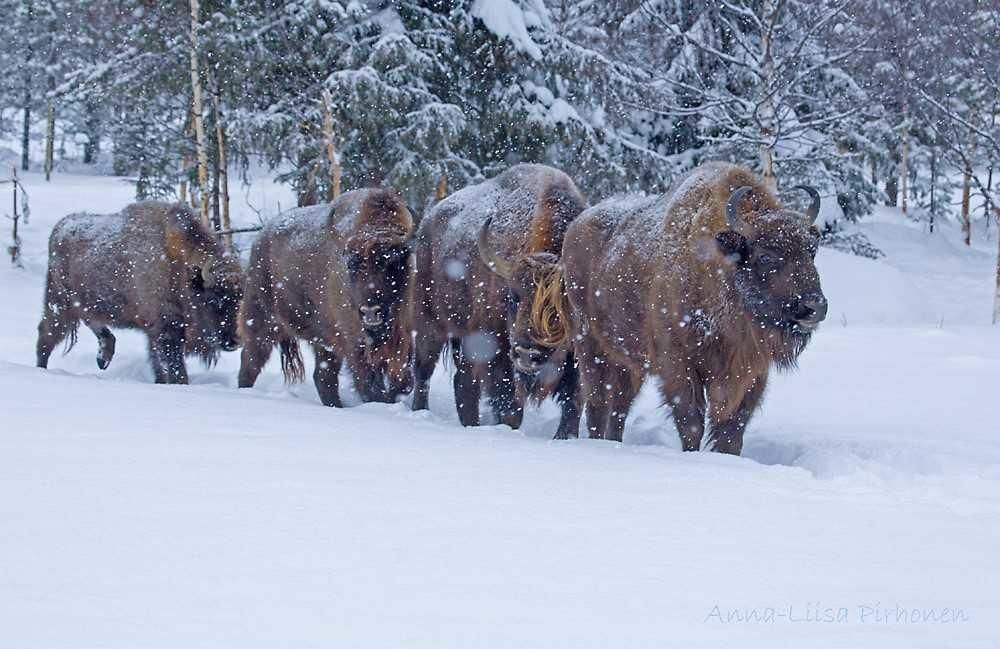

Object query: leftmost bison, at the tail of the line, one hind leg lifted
[37,201,241,383]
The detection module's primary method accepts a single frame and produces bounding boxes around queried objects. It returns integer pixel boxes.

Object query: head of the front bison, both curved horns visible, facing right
[716,185,827,339]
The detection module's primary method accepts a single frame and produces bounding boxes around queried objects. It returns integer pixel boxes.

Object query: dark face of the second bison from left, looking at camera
[345,236,411,347]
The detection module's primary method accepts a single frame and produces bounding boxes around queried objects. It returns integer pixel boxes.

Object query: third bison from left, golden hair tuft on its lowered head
[413,164,586,438]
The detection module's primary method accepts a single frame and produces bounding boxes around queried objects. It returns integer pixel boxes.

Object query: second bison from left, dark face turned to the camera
[239,188,413,407]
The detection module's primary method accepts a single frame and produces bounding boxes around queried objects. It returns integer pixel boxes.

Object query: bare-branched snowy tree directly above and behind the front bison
[641,0,869,200]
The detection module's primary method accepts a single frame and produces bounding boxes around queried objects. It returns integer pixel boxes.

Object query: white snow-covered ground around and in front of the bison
[0,175,1000,649]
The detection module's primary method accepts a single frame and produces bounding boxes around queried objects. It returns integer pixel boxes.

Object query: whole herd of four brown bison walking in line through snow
[37,162,827,454]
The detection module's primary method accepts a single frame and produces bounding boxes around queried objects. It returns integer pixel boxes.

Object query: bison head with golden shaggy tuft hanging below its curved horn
[479,218,569,398]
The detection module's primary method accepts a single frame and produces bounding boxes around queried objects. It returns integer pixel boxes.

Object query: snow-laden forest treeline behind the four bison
[0,0,1000,238]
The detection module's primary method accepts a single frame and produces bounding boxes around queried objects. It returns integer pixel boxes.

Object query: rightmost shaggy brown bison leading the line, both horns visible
[563,162,827,454]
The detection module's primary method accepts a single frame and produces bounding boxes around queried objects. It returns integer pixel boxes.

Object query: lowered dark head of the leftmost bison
[191,255,243,356]
